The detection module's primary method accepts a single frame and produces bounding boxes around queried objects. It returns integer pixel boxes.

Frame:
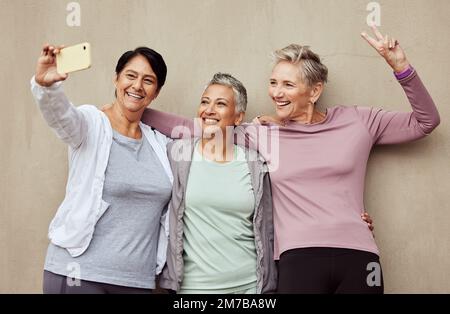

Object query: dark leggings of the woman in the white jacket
[43,270,152,294]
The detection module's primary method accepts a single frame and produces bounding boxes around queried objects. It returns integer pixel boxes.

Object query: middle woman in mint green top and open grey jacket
[160,73,277,294]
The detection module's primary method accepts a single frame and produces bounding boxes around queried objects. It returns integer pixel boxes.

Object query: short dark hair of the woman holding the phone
[116,47,167,91]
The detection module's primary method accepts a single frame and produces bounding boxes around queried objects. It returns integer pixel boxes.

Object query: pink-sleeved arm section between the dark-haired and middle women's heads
[141,108,197,139]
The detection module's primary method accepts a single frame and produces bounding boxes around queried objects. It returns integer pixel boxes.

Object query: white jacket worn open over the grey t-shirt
[31,77,173,274]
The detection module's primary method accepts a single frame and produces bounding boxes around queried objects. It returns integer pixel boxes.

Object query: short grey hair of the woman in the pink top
[272,44,328,87]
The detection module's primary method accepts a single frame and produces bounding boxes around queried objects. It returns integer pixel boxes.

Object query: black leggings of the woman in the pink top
[278,248,384,294]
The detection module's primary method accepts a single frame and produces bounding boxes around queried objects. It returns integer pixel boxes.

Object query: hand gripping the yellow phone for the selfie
[35,44,68,87]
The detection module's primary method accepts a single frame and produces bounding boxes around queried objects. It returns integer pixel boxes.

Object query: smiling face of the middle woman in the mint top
[198,84,244,135]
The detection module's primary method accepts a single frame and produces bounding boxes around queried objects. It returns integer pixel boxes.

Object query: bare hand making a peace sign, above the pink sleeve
[361,26,409,73]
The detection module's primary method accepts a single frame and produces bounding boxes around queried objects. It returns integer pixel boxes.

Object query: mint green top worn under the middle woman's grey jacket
[180,142,256,293]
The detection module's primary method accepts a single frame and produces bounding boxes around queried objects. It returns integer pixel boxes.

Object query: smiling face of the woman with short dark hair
[115,55,158,113]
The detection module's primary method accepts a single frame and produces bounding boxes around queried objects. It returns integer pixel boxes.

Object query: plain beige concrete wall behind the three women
[0,0,450,293]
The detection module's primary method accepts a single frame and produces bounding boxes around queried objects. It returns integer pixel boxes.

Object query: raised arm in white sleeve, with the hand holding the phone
[31,45,87,148]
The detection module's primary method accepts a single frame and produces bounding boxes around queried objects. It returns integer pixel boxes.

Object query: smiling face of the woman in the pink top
[269,61,322,120]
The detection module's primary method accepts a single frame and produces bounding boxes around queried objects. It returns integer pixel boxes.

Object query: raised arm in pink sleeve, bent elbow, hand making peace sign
[357,26,440,144]
